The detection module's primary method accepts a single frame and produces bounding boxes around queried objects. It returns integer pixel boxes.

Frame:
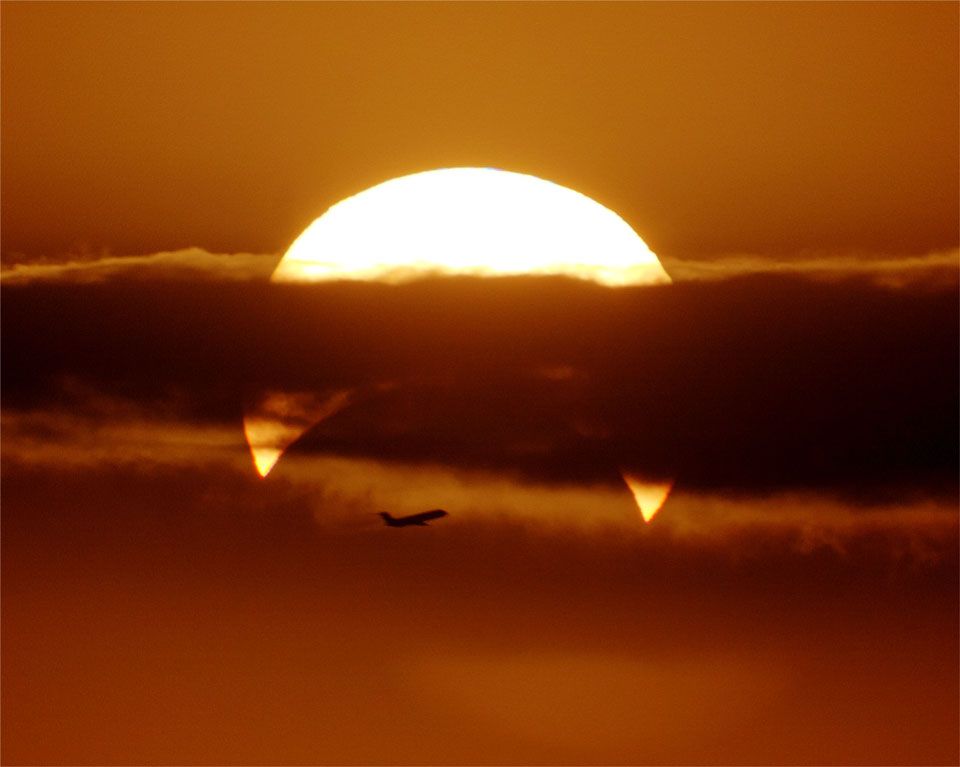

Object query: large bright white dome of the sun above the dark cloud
[272,168,670,286]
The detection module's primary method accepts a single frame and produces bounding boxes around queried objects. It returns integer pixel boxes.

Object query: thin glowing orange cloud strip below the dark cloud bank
[0,395,958,564]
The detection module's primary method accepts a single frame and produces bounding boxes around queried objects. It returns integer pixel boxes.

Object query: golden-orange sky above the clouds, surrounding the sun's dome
[2,2,960,260]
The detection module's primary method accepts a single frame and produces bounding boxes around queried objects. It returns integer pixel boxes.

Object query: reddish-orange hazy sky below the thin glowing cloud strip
[2,452,960,765]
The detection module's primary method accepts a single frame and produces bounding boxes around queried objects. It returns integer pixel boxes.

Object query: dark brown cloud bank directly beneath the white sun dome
[2,276,958,501]
